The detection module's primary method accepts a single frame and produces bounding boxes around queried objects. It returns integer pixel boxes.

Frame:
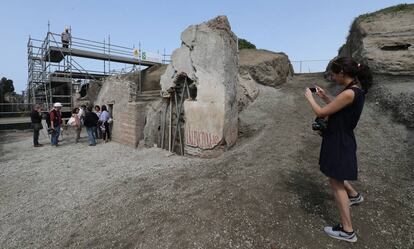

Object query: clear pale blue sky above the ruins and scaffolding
[0,0,414,93]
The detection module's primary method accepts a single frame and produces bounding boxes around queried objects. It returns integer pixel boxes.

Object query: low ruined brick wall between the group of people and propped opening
[95,65,166,147]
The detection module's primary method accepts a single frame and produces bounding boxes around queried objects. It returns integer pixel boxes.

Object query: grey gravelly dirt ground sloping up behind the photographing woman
[0,74,414,249]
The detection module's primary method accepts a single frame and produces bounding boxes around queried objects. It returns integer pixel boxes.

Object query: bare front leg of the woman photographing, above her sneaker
[329,178,354,232]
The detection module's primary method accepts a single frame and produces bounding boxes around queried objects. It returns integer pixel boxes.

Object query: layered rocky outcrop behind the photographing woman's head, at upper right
[339,4,414,75]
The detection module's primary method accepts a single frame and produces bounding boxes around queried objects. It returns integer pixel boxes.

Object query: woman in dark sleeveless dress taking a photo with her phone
[305,58,372,242]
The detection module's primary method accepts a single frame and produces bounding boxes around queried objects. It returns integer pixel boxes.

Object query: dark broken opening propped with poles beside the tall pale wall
[161,73,197,155]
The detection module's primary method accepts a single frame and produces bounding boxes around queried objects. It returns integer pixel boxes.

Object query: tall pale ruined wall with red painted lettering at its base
[161,16,238,156]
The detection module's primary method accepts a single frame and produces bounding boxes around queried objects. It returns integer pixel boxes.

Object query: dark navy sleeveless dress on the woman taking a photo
[319,86,365,180]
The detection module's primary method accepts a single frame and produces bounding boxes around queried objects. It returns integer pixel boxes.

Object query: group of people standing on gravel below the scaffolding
[31,102,112,147]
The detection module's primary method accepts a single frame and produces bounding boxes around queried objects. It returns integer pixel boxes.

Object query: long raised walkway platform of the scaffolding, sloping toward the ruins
[44,46,161,67]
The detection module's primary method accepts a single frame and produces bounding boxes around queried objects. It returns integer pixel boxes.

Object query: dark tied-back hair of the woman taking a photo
[331,57,373,93]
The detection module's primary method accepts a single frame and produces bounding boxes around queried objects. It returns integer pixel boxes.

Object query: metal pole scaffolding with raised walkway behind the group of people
[26,31,165,112]
